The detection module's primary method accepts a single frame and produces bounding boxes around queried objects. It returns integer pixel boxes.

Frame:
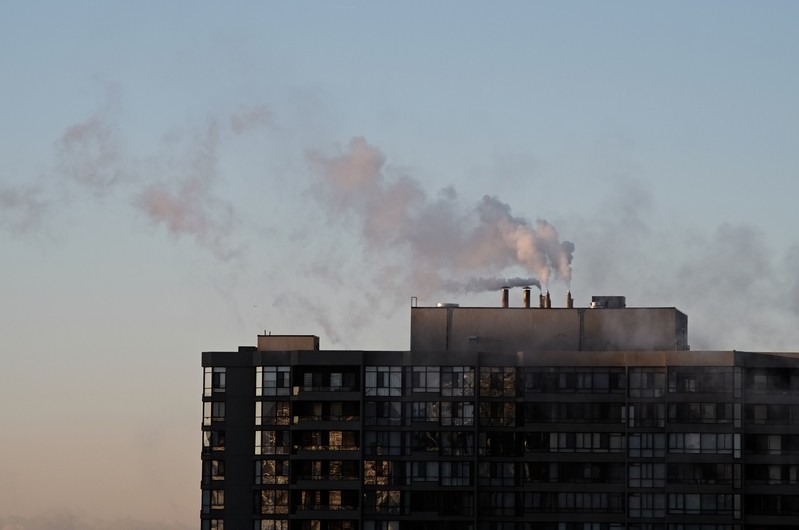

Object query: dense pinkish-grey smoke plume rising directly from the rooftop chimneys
[307,138,574,291]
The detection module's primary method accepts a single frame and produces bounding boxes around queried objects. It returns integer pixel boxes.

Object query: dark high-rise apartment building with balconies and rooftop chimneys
[201,290,799,530]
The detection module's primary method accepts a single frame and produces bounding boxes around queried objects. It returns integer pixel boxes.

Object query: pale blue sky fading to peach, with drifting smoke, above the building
[0,0,799,530]
